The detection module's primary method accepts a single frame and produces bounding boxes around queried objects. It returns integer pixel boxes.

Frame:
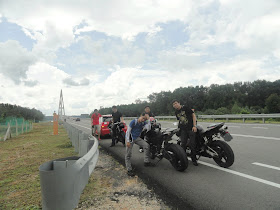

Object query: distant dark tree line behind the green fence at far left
[0,103,44,121]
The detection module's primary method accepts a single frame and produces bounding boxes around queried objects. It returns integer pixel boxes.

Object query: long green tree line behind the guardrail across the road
[99,80,280,117]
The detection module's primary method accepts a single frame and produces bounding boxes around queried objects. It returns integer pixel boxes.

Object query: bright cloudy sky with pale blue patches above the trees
[0,0,280,115]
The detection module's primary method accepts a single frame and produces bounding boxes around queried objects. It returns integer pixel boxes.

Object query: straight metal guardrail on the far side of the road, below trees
[125,113,280,123]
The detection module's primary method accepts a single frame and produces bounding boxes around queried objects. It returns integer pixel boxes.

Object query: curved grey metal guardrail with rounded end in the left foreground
[39,122,99,210]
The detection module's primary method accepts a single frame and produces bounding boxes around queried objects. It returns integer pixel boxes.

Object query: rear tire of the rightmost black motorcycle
[210,140,234,168]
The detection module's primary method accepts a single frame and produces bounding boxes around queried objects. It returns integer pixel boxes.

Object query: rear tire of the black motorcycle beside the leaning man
[167,144,189,172]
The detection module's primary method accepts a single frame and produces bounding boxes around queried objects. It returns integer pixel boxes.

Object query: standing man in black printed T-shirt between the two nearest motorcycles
[172,100,198,166]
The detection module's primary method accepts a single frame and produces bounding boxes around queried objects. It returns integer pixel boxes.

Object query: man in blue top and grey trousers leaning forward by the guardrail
[125,113,155,176]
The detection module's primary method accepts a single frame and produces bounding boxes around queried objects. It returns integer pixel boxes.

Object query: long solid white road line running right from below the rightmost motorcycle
[188,158,280,189]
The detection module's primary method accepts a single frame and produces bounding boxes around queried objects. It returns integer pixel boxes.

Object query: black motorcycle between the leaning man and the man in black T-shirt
[142,120,188,171]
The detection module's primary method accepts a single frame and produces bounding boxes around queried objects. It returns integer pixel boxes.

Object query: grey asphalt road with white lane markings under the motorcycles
[66,120,280,209]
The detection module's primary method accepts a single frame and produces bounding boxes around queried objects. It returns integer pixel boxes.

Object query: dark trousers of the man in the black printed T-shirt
[181,129,196,160]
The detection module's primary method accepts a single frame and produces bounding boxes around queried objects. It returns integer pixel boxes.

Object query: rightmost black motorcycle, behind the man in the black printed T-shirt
[177,123,234,168]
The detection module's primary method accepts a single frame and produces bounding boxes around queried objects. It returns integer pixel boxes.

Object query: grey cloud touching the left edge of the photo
[0,40,36,84]
